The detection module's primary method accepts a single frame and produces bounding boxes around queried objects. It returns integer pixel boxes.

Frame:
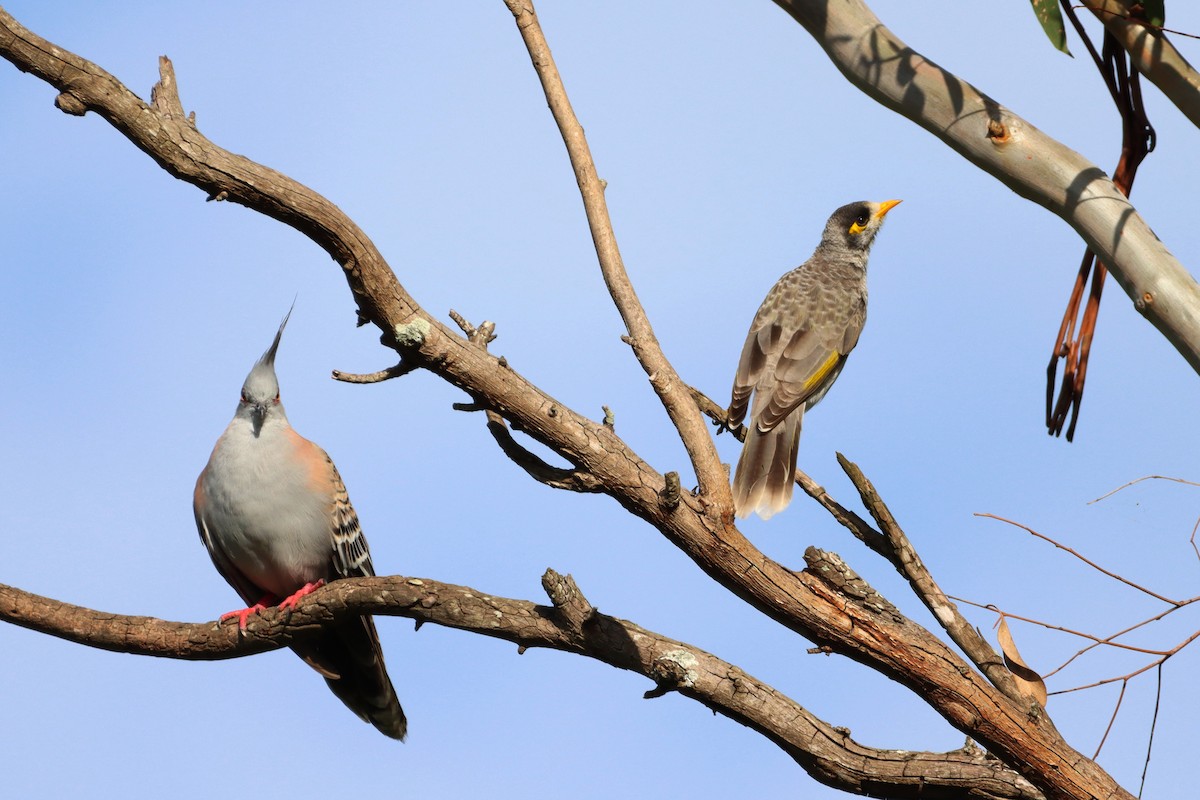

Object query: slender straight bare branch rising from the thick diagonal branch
[505,0,733,509]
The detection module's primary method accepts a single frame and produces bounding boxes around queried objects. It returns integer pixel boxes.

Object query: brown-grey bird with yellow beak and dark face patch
[727,200,900,519]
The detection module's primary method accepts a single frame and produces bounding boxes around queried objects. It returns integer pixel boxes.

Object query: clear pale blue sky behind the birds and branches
[0,0,1200,798]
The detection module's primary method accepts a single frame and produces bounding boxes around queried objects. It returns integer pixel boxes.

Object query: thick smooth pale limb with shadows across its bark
[775,0,1200,372]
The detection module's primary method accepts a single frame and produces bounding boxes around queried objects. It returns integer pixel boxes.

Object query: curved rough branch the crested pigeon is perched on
[0,578,1043,800]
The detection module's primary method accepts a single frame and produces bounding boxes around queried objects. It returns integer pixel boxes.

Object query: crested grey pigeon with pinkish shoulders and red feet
[193,311,407,740]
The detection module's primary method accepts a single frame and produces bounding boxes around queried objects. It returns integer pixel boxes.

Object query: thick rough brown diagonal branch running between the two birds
[0,10,1132,798]
